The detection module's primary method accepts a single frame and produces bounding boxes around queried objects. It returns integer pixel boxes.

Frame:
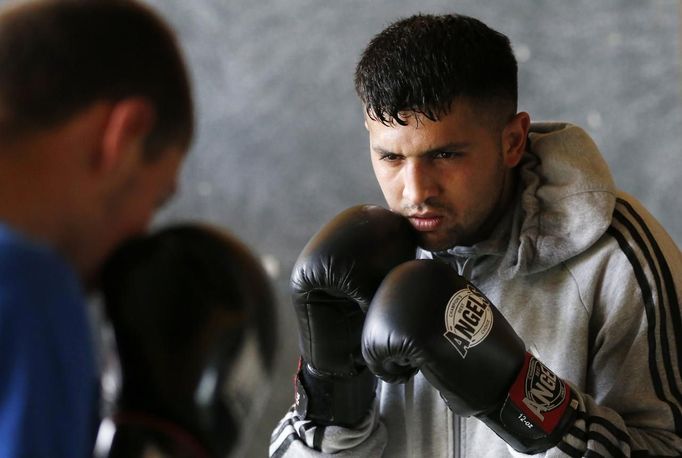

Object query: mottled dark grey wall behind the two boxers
[122,0,682,456]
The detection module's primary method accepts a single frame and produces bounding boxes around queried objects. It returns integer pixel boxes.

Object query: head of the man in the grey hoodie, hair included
[355,15,530,251]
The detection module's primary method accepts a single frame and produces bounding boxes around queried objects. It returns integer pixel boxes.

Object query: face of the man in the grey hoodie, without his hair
[365,101,520,251]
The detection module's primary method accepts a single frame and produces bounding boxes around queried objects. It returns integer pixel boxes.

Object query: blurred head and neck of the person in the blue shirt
[0,0,194,277]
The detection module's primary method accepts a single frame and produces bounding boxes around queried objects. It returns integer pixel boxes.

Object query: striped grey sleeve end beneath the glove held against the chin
[269,400,387,458]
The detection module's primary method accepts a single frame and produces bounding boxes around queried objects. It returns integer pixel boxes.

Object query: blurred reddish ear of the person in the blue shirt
[95,97,156,170]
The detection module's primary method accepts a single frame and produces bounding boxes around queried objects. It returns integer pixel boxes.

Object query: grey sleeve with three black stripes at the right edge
[546,197,682,457]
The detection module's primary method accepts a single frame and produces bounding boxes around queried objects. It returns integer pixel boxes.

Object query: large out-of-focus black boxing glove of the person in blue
[95,225,276,458]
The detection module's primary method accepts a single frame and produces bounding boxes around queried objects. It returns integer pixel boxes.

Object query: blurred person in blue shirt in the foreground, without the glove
[0,0,194,458]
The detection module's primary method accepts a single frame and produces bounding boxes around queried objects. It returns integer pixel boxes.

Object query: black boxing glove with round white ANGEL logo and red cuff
[362,260,577,453]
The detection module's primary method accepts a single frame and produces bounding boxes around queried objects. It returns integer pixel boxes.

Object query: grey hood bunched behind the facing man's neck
[423,123,616,279]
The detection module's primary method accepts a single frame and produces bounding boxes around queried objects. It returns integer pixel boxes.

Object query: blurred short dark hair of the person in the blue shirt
[0,0,194,155]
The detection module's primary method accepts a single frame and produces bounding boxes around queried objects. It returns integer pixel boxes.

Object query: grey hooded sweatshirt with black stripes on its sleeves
[270,123,682,458]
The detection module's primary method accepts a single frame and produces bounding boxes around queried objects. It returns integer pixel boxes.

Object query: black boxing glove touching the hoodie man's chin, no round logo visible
[291,205,417,426]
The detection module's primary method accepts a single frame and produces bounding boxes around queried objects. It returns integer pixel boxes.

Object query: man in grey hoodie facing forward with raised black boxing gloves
[270,15,682,458]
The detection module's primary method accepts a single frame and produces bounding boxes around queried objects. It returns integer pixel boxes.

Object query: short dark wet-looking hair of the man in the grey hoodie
[355,14,517,125]
